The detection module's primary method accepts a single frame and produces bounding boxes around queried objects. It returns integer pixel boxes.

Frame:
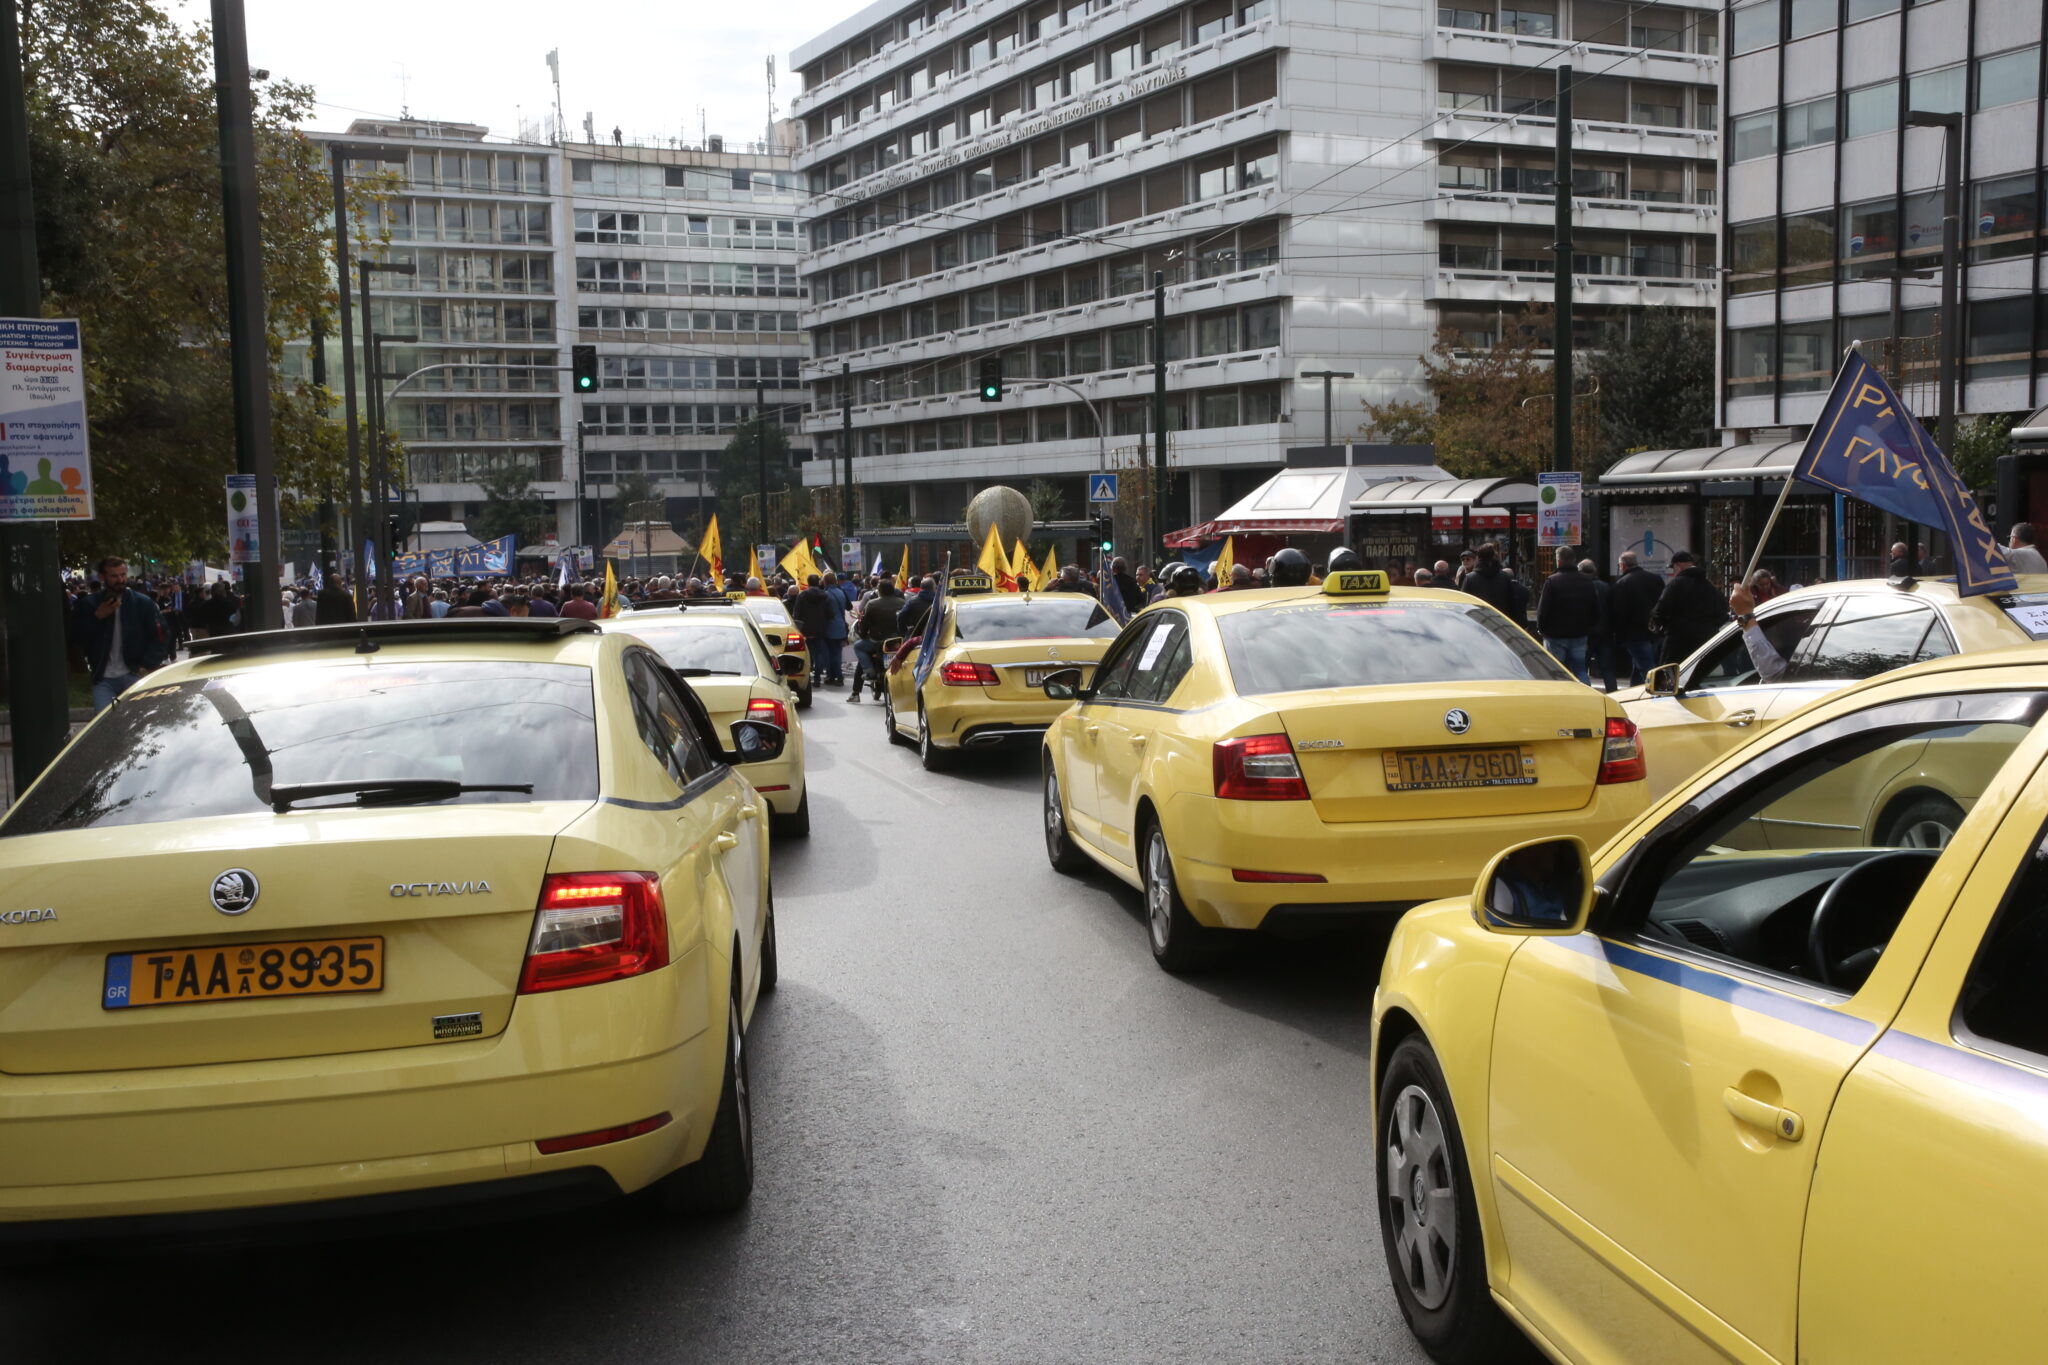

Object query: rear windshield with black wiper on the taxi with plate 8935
[0,655,598,837]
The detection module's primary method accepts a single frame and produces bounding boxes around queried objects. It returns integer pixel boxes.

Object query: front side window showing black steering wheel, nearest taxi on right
[1622,694,2044,993]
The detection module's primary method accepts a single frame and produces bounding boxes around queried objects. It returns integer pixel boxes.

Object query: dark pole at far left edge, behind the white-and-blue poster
[0,4,72,792]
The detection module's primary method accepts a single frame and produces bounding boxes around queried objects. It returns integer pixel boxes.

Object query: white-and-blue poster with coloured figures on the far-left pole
[0,317,92,522]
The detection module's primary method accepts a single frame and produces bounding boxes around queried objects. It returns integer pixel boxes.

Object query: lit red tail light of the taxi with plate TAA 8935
[518,872,668,995]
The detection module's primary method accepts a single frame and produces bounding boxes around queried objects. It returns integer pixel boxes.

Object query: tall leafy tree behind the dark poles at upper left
[18,0,344,561]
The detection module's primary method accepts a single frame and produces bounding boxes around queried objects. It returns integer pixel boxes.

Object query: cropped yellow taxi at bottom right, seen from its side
[1372,645,2048,1365]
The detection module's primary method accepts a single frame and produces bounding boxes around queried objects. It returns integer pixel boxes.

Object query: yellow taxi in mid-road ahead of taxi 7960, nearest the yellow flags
[883,573,1116,769]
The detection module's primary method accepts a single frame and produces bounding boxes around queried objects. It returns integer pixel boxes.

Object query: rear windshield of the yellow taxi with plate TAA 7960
[1217,600,1571,696]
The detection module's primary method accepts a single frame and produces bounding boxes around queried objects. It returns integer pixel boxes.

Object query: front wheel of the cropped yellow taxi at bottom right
[1374,1036,1534,1365]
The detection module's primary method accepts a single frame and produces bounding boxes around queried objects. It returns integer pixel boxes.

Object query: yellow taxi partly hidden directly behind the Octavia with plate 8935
[600,598,811,839]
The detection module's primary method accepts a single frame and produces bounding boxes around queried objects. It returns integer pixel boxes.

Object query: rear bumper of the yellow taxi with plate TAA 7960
[1163,782,1647,929]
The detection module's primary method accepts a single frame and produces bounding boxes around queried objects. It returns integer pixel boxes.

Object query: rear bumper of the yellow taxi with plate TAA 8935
[0,945,725,1234]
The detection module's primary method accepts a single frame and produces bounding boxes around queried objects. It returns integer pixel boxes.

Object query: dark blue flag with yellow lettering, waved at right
[1792,350,2017,598]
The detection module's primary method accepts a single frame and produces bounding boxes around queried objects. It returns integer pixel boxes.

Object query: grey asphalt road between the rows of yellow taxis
[0,692,1425,1365]
